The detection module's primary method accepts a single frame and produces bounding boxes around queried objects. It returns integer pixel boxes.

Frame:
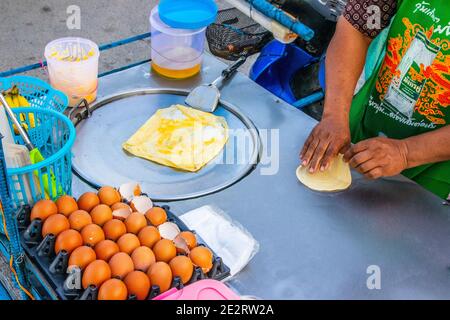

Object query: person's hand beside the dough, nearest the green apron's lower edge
[344,137,408,179]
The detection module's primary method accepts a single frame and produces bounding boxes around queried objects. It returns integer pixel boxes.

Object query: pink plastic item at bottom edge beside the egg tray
[153,279,240,300]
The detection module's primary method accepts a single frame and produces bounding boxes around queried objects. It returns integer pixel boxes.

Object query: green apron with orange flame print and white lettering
[350,0,450,199]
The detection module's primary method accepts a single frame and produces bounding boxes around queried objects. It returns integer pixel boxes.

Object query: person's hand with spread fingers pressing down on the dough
[300,117,350,173]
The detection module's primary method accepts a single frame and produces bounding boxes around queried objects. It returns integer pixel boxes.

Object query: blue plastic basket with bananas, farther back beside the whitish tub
[0,76,69,112]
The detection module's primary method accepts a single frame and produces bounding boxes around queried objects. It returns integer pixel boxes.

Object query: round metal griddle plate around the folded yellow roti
[72,89,260,201]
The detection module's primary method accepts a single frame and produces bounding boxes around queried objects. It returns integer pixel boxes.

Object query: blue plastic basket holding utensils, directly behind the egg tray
[3,107,75,208]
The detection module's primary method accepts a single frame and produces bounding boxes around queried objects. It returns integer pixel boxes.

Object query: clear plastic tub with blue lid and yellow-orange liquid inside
[150,0,217,79]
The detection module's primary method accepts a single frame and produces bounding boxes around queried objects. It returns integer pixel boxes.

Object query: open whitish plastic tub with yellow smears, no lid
[45,38,100,107]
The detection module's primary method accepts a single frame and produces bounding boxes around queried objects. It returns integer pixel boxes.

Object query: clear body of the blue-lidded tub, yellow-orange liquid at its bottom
[150,7,206,79]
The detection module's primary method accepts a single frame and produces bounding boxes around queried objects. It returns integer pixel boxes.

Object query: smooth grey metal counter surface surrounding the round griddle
[73,55,450,299]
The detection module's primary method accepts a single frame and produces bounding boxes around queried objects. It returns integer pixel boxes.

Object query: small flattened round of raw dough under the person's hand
[296,154,352,192]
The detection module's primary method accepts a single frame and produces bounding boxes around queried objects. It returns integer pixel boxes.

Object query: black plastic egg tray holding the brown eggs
[17,205,230,300]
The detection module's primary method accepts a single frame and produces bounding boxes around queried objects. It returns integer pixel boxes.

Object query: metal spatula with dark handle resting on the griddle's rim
[184,56,247,112]
